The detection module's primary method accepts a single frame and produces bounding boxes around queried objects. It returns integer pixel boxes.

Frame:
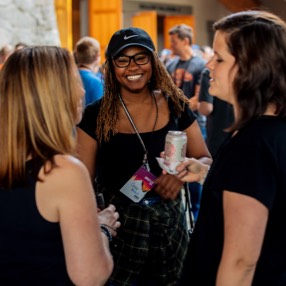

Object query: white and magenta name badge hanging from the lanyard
[120,166,156,203]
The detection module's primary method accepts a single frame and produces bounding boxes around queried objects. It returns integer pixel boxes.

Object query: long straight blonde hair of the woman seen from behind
[0,47,82,187]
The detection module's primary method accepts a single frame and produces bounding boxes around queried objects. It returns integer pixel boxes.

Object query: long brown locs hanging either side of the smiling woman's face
[95,52,190,143]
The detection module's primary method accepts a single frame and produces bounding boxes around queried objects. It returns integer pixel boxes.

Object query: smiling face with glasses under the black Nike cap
[113,46,152,93]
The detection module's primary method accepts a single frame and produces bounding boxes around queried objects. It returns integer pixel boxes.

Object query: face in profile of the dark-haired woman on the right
[207,31,237,104]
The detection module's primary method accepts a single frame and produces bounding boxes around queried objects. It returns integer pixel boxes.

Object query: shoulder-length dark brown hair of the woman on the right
[214,11,286,129]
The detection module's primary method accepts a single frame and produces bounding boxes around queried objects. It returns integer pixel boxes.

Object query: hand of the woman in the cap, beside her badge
[154,174,184,200]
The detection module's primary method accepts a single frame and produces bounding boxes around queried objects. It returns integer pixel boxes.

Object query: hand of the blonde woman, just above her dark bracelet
[98,205,121,236]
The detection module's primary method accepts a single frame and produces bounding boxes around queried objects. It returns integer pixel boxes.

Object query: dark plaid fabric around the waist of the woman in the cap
[108,194,188,286]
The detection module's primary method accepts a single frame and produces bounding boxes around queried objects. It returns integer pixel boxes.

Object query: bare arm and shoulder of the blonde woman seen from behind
[37,155,118,285]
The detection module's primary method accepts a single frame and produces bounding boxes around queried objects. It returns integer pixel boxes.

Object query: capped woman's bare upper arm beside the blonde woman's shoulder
[77,128,98,182]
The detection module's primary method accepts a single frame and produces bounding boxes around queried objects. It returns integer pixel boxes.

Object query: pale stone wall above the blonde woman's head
[0,0,60,48]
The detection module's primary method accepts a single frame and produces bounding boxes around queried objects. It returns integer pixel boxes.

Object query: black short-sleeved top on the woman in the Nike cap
[78,96,196,197]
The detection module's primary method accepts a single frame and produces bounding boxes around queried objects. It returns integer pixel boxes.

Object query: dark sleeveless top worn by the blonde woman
[0,160,73,286]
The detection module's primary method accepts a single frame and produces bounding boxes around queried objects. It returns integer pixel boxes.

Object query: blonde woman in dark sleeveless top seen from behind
[0,47,120,285]
